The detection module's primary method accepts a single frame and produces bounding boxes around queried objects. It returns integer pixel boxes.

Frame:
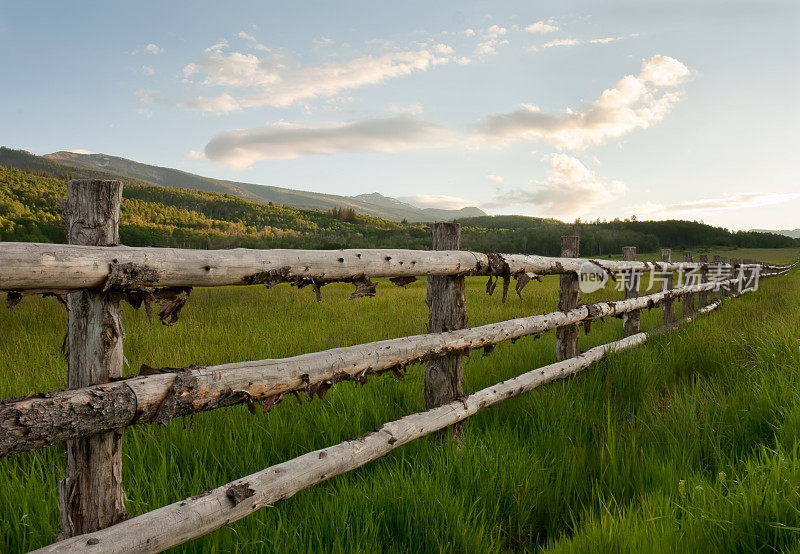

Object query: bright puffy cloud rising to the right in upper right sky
[478,55,691,149]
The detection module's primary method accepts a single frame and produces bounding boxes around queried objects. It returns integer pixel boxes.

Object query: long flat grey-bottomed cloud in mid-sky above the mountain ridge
[205,116,457,169]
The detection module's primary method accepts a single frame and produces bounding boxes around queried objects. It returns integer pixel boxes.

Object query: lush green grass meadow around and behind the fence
[0,250,800,553]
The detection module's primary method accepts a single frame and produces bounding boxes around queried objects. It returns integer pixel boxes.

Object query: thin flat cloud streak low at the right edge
[631,192,800,217]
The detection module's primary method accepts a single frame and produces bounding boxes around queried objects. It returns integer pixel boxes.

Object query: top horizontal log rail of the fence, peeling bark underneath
[0,242,732,292]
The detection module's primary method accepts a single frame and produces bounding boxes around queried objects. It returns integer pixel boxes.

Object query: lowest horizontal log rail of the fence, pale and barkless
[36,302,719,553]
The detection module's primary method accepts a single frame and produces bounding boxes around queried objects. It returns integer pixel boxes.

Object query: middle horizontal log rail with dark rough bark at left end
[0,279,737,456]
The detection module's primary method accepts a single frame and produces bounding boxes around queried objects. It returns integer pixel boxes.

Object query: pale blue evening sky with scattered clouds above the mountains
[0,0,800,229]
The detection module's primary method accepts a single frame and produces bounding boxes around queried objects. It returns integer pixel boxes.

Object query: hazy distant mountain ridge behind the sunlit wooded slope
[0,147,486,223]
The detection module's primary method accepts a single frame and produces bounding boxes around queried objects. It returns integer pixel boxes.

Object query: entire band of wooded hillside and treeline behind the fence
[0,166,800,251]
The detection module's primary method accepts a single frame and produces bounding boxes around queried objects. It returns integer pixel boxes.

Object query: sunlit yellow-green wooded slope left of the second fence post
[0,166,429,248]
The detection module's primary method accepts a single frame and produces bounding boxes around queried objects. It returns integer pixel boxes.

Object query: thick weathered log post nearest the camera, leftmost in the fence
[58,179,128,538]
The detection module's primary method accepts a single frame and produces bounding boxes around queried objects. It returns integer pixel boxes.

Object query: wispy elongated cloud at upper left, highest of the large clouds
[182,42,456,112]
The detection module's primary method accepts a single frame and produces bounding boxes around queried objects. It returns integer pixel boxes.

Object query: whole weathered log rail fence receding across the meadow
[0,180,795,552]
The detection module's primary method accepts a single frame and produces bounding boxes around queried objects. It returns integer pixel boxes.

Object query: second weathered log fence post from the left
[425,223,467,426]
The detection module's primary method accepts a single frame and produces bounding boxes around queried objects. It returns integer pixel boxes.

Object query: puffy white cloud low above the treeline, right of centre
[492,154,626,218]
